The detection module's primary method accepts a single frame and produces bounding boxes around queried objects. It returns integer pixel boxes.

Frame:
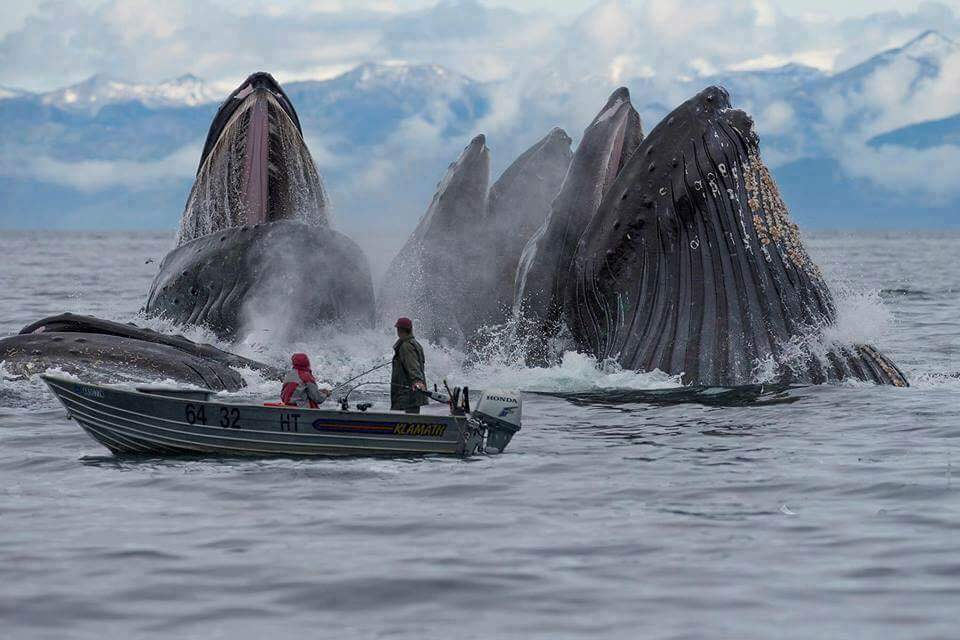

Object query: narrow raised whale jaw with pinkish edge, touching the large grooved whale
[513,87,643,363]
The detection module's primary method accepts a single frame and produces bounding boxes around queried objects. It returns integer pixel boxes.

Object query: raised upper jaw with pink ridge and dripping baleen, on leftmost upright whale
[177,73,327,245]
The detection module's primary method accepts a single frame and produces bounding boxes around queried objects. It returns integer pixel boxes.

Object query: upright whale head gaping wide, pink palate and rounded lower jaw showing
[145,73,373,339]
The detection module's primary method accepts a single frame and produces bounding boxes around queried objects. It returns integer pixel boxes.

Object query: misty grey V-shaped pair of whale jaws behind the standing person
[379,128,571,346]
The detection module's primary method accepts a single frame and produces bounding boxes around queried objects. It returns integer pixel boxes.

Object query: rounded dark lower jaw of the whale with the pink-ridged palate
[145,221,374,339]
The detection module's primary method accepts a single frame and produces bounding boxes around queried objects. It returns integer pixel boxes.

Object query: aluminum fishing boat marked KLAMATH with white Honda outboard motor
[41,374,521,456]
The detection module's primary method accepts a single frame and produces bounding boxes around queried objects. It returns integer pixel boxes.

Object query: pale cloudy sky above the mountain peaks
[0,0,960,91]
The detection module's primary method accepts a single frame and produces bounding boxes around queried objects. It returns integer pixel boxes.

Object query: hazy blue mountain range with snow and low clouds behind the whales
[0,31,960,237]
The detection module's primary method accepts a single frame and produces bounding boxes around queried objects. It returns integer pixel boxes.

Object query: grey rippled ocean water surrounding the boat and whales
[0,232,960,640]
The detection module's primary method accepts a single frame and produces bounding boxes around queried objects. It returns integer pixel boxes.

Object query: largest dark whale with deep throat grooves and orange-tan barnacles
[557,87,907,386]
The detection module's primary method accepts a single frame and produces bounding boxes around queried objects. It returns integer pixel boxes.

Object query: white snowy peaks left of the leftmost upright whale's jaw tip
[40,74,223,113]
